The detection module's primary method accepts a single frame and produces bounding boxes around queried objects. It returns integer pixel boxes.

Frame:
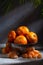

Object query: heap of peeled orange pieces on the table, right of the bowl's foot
[22,50,42,58]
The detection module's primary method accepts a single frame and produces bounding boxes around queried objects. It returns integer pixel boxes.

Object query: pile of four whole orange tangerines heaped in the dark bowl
[8,26,38,45]
